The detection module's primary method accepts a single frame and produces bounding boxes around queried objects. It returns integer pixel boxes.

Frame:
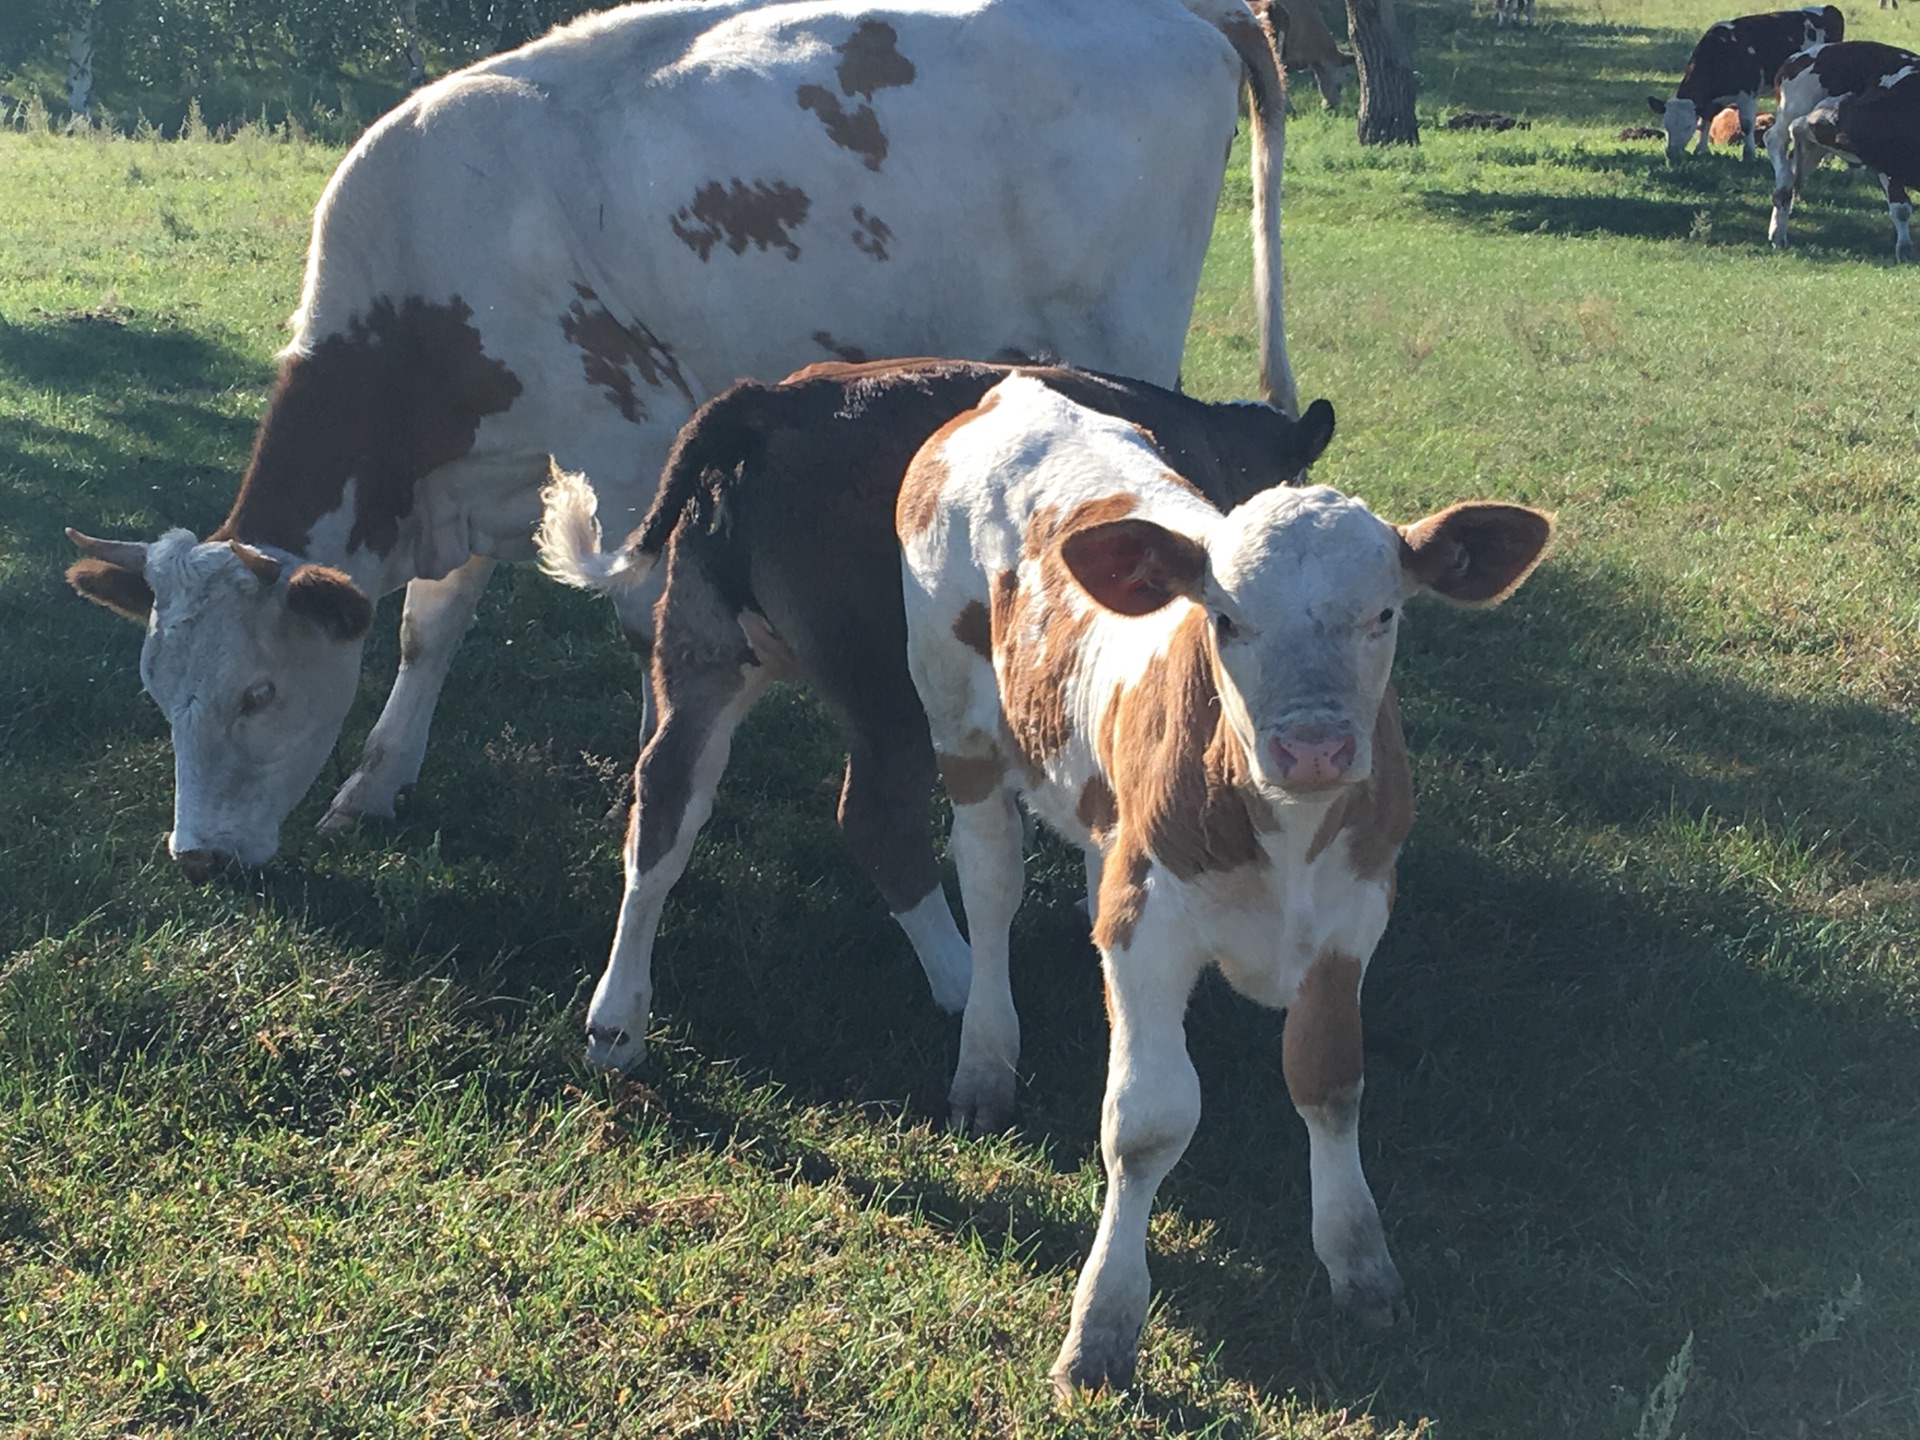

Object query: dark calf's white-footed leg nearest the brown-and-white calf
[839,733,972,1014]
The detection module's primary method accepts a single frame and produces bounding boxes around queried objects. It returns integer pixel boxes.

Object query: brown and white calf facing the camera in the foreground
[899,376,1551,1388]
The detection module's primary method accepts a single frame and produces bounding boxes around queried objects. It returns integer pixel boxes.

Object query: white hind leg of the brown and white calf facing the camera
[941,771,1025,1135]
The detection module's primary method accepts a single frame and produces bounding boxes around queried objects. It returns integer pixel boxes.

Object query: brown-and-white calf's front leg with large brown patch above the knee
[1281,952,1402,1325]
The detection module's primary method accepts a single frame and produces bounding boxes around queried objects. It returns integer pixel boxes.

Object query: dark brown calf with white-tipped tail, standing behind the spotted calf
[540,359,1332,1075]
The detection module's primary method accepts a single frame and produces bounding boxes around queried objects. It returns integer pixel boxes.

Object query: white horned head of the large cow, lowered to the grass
[67,530,372,879]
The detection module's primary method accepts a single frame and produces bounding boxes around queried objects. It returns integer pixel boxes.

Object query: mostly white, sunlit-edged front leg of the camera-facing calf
[1052,931,1200,1394]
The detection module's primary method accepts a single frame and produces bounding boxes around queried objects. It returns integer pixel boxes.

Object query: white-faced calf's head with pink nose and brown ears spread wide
[1060,486,1553,801]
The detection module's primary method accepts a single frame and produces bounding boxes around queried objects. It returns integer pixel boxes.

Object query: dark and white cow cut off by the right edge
[1766,40,1920,259]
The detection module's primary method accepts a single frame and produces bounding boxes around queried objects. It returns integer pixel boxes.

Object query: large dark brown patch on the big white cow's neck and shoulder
[207,296,520,555]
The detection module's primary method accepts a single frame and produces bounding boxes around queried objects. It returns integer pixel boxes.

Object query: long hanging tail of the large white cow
[1185,0,1300,415]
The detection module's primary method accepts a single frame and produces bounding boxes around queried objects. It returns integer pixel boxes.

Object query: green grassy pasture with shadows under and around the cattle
[0,0,1920,1440]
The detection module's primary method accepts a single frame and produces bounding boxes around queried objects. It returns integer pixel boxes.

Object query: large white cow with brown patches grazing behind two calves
[69,0,1292,876]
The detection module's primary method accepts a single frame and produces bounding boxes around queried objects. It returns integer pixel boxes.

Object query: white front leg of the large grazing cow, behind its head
[319,555,493,833]
